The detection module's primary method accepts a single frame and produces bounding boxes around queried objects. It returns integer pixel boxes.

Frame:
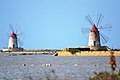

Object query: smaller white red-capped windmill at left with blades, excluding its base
[8,24,23,49]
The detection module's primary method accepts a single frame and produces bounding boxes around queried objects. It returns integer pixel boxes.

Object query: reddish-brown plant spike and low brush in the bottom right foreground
[89,51,120,80]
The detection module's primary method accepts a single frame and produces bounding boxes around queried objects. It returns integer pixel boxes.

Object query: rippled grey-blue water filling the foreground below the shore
[0,54,120,80]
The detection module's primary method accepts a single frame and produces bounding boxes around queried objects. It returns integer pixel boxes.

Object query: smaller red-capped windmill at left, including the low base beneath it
[2,24,23,52]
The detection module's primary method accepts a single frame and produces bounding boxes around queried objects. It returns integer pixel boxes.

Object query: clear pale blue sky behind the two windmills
[0,0,120,49]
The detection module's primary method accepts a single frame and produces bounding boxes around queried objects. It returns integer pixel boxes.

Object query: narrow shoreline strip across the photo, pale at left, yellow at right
[0,51,120,56]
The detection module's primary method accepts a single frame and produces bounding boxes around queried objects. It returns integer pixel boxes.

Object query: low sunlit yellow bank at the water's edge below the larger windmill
[56,51,120,56]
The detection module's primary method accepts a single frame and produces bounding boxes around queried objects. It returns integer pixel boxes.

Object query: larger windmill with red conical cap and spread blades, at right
[81,14,112,47]
